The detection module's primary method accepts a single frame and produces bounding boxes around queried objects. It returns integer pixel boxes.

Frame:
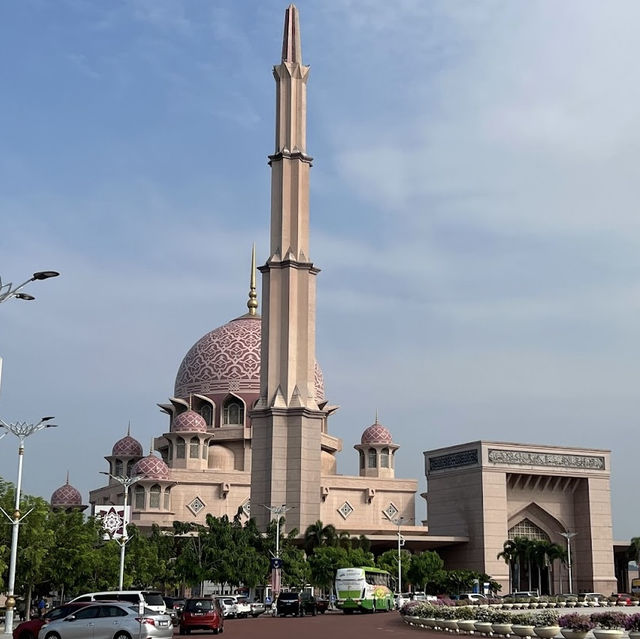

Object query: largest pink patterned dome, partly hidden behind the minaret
[174,314,324,402]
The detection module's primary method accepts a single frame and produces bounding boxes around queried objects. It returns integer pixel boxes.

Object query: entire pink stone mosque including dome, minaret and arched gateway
[81,5,618,593]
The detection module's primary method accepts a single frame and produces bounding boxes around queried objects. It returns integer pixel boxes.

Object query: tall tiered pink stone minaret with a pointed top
[251,5,327,533]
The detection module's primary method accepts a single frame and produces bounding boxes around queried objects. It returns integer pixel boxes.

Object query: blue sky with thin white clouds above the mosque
[0,0,640,539]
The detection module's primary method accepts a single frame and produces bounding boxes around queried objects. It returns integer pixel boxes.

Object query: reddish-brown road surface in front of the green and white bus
[174,612,432,639]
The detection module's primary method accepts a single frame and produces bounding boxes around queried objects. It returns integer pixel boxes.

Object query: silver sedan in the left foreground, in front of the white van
[38,601,173,639]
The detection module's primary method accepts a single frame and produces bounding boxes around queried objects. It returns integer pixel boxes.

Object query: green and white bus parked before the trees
[335,566,393,614]
